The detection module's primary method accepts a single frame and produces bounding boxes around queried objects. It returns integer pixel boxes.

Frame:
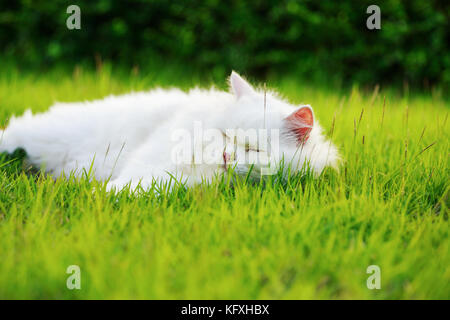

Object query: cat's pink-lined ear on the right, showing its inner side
[285,105,314,144]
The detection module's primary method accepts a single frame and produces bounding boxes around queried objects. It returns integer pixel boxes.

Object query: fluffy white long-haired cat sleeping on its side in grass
[0,72,338,189]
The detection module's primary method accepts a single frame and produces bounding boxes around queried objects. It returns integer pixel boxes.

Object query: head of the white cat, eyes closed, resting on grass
[221,72,339,177]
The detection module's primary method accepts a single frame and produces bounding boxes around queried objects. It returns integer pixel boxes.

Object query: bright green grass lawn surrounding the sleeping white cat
[0,66,450,299]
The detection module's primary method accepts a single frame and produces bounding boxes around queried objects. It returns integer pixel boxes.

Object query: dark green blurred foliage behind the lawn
[0,0,450,88]
